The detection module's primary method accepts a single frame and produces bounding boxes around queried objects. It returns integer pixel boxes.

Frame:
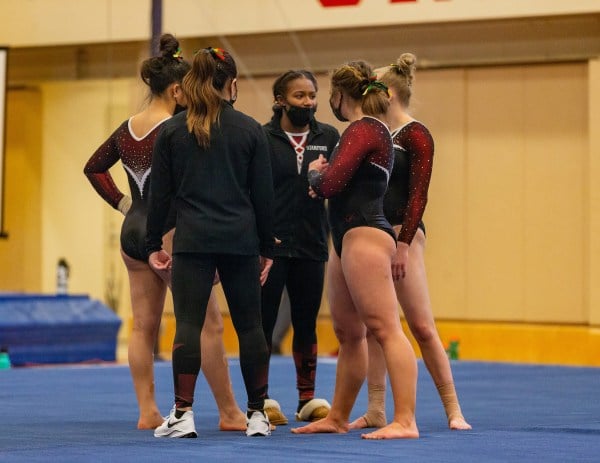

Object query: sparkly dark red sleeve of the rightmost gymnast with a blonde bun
[398,124,434,245]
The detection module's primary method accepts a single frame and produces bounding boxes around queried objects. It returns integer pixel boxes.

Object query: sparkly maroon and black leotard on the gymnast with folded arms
[309,117,396,256]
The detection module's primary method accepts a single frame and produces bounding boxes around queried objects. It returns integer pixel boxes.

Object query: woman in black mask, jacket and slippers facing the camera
[262,70,339,425]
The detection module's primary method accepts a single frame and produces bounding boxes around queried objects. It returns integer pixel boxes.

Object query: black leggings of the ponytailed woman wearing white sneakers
[172,253,269,410]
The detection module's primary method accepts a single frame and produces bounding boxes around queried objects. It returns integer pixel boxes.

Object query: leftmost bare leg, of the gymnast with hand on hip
[121,252,167,429]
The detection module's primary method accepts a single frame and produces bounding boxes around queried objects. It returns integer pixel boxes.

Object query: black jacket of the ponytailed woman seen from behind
[146,101,274,257]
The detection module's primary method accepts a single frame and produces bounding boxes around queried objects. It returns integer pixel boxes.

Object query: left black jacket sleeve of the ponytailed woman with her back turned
[146,129,174,255]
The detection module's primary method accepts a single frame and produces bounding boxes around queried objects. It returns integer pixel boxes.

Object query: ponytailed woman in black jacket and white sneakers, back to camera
[146,47,273,437]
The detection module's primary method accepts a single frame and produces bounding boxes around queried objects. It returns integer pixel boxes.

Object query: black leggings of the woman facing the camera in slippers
[262,257,325,400]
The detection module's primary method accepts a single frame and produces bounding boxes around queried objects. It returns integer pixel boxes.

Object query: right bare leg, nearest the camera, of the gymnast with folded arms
[342,227,419,439]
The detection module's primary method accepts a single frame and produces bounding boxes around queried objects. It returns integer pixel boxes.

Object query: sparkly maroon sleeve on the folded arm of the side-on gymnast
[308,120,372,198]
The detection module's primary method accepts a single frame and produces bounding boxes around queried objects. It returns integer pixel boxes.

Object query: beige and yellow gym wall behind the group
[0,62,600,330]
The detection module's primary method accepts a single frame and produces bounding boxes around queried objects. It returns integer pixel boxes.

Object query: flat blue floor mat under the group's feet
[0,356,600,463]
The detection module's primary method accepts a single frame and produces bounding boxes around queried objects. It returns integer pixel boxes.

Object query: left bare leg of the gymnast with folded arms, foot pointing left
[292,251,367,434]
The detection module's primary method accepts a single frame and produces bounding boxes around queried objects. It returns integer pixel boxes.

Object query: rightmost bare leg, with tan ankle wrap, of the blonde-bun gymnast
[396,230,471,430]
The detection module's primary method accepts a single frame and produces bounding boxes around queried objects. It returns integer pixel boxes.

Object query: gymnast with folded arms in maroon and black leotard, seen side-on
[292,61,419,439]
